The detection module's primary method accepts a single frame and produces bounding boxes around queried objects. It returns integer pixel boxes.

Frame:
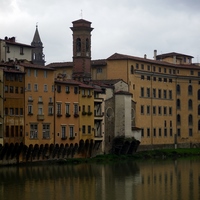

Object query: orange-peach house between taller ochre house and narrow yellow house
[55,77,80,147]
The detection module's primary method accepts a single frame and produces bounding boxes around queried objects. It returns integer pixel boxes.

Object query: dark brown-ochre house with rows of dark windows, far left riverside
[3,64,24,144]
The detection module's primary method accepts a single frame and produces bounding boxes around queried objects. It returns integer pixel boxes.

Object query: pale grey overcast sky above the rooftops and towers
[0,0,200,64]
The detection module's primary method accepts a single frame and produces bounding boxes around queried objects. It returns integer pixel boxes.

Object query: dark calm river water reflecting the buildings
[0,158,200,200]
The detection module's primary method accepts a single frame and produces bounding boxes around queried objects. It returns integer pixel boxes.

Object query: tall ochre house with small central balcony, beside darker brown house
[19,63,55,146]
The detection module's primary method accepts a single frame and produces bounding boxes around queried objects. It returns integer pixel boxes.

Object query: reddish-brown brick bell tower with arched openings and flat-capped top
[70,19,93,82]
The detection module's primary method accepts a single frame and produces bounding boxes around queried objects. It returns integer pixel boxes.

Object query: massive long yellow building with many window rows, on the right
[92,53,200,149]
